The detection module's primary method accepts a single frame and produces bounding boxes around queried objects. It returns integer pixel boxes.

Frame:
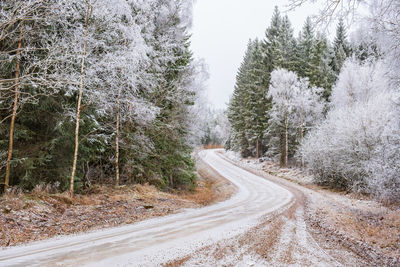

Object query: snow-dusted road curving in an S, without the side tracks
[0,150,293,266]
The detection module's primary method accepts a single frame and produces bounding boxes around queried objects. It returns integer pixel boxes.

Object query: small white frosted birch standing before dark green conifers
[267,69,324,167]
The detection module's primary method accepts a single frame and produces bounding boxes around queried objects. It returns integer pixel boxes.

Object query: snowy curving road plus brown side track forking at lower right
[0,150,390,266]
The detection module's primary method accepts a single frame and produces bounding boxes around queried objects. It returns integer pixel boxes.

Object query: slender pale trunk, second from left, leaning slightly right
[69,3,92,197]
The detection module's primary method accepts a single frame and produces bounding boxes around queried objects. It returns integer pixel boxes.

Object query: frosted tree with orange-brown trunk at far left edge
[0,0,72,191]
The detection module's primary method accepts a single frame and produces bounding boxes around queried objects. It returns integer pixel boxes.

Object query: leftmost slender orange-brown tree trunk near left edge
[4,17,24,191]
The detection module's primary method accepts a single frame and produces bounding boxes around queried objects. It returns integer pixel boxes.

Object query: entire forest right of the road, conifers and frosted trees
[225,1,400,200]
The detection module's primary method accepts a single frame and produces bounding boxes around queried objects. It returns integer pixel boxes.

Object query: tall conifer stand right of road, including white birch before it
[227,7,352,161]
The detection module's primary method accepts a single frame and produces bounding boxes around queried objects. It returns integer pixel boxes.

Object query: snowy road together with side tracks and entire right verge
[0,150,400,266]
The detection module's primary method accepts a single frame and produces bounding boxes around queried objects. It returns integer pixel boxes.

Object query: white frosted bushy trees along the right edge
[292,0,400,201]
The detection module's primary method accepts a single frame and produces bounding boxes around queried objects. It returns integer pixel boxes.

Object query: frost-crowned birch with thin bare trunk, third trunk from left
[90,1,158,186]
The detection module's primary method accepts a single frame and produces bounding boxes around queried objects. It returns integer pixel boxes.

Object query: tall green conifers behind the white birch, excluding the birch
[228,7,335,161]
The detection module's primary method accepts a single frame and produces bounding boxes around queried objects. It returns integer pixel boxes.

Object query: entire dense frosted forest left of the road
[0,0,199,194]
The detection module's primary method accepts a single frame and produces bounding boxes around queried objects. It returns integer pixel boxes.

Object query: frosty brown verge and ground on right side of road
[224,152,400,266]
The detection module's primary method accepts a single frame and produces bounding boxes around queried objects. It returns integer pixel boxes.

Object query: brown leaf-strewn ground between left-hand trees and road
[0,156,235,247]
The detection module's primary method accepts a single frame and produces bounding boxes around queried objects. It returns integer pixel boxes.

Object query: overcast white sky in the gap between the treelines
[192,0,324,108]
